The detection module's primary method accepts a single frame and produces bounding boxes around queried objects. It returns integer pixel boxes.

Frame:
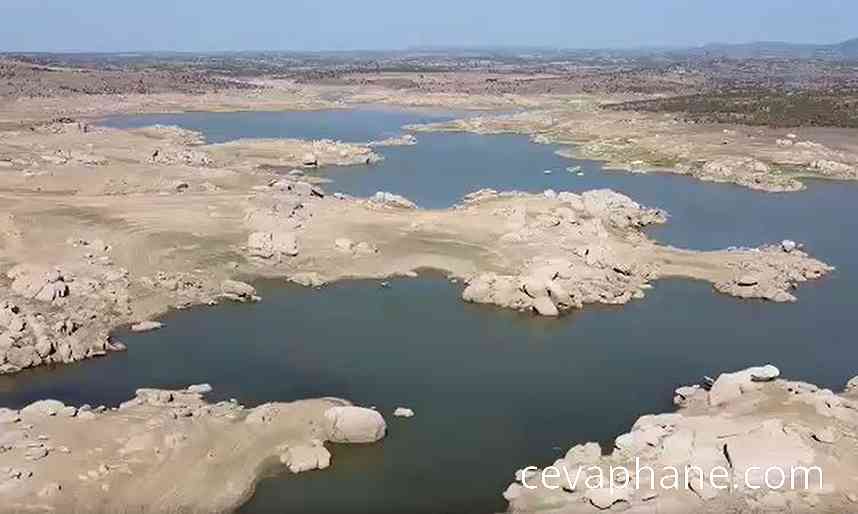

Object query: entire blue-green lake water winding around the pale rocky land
[6,111,858,514]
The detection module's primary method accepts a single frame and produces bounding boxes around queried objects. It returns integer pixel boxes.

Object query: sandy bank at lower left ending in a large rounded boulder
[0,384,384,514]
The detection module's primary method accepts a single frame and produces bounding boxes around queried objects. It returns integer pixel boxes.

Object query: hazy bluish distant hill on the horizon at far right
[686,38,858,59]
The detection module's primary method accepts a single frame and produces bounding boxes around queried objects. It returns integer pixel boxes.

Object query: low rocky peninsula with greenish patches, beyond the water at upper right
[410,109,858,192]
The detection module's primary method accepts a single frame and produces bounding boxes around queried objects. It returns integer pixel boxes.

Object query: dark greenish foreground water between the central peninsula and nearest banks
[0,277,858,513]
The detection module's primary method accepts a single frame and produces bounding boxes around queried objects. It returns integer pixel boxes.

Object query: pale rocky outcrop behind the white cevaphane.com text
[504,365,858,514]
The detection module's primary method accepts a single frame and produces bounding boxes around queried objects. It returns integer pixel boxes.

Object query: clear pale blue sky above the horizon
[0,0,858,52]
